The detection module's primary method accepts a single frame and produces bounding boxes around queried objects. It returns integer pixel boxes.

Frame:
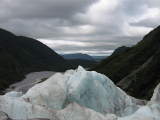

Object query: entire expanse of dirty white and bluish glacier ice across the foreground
[0,66,160,120]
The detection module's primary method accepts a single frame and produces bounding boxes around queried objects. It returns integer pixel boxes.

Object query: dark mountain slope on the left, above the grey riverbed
[0,29,69,91]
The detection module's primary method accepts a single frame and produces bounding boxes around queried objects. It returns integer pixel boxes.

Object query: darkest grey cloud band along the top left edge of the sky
[0,0,96,19]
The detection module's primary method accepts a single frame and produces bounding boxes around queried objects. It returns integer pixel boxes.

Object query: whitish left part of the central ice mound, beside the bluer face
[22,71,73,109]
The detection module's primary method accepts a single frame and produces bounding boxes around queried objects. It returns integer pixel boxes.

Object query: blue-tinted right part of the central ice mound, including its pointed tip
[66,67,138,116]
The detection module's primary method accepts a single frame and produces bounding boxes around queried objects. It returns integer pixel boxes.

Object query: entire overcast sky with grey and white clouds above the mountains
[0,0,160,55]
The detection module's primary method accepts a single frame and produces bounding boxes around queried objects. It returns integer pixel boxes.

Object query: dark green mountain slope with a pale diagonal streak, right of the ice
[93,27,160,98]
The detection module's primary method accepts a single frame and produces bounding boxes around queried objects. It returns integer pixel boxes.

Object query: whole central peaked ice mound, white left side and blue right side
[23,67,141,116]
